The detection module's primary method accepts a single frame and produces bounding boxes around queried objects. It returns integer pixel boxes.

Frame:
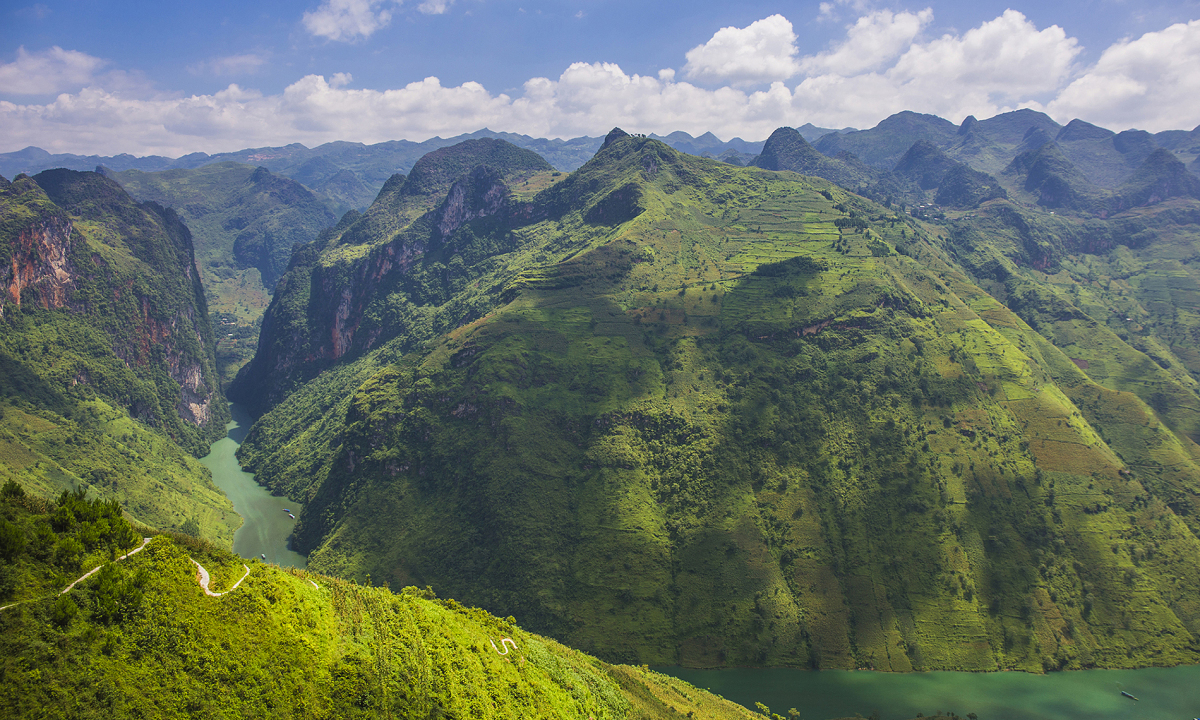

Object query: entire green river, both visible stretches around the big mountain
[200,404,1200,720]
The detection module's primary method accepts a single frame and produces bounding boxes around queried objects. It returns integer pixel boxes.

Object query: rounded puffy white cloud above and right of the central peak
[683,14,799,85]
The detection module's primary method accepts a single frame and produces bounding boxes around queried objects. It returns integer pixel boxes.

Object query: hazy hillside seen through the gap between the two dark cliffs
[108,162,343,383]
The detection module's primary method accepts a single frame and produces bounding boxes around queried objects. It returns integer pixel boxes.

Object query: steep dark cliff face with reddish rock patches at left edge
[0,170,227,452]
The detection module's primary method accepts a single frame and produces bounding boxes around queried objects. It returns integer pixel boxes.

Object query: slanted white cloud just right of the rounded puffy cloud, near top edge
[799,7,934,74]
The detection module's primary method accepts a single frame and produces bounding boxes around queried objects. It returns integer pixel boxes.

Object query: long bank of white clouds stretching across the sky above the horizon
[0,5,1200,156]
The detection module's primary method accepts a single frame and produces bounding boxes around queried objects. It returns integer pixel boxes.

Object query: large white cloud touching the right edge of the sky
[1046,20,1200,132]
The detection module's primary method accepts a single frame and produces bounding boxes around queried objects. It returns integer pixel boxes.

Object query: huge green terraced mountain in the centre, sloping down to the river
[244,131,1200,670]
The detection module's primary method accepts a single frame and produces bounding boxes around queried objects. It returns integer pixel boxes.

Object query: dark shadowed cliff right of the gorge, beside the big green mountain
[230,140,548,410]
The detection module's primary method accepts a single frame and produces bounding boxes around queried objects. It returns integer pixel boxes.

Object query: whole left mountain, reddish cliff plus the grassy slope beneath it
[0,170,240,541]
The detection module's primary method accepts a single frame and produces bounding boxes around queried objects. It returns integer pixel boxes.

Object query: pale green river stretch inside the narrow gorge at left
[200,403,307,568]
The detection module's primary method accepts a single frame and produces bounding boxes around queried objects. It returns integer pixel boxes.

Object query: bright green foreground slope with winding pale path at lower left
[0,496,755,720]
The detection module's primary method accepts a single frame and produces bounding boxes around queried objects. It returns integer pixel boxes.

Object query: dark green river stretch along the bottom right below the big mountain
[655,665,1200,720]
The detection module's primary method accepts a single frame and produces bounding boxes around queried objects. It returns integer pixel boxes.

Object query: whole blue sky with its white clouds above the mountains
[0,0,1200,157]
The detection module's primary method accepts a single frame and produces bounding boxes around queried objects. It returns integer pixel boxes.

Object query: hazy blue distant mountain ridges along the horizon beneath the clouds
[0,109,1200,210]
